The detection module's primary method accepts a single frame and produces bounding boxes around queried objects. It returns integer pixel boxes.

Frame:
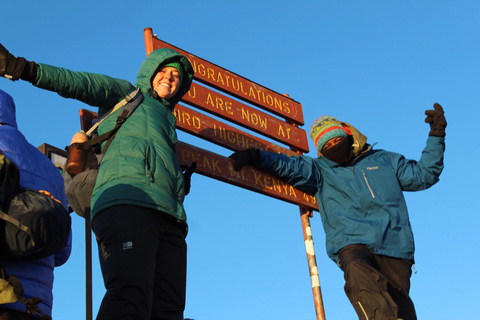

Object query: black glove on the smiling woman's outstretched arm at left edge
[0,44,38,82]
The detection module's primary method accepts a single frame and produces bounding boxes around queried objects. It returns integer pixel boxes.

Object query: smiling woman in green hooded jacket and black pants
[0,46,193,320]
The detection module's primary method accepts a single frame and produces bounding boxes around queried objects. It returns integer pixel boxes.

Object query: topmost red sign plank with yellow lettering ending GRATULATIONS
[145,28,304,125]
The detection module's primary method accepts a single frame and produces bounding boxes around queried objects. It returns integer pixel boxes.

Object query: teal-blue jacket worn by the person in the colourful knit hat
[257,125,445,262]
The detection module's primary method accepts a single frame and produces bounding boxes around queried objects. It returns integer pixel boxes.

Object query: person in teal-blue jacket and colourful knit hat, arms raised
[230,103,447,320]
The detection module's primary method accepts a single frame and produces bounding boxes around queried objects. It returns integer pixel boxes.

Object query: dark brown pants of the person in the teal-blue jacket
[338,244,417,320]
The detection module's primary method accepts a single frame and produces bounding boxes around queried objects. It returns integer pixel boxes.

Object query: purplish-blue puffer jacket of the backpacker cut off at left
[0,90,72,320]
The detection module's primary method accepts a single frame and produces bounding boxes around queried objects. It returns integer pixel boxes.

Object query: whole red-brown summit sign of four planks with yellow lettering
[145,28,318,210]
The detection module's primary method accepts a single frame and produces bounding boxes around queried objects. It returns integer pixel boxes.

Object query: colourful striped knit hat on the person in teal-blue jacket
[310,116,348,152]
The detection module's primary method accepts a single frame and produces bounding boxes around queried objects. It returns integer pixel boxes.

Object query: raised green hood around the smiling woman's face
[135,48,194,108]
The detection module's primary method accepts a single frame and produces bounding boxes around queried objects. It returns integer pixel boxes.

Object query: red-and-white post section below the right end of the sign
[300,207,325,320]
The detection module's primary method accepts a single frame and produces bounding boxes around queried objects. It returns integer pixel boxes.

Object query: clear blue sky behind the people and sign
[0,0,480,320]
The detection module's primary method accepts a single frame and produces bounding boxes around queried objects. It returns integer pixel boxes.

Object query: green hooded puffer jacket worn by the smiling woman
[34,48,194,221]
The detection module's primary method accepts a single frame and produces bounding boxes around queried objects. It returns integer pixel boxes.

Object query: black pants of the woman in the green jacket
[93,205,187,320]
